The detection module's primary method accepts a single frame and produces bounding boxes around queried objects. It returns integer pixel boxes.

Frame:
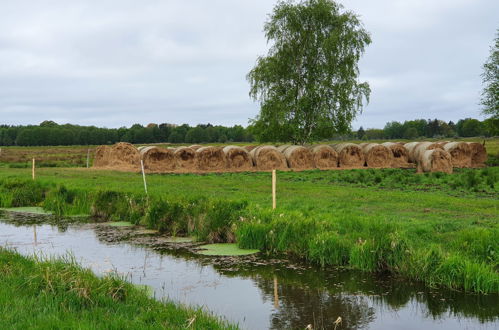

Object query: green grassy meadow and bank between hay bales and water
[0,168,499,293]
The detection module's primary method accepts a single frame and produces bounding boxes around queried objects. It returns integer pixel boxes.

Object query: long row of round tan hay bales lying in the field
[94,142,487,173]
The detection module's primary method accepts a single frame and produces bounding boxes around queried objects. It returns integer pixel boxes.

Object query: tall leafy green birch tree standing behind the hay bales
[247,0,371,144]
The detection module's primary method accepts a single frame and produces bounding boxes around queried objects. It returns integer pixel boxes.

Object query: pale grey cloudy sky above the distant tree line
[0,0,499,128]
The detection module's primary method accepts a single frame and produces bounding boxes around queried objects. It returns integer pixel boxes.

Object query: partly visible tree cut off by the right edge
[481,29,499,118]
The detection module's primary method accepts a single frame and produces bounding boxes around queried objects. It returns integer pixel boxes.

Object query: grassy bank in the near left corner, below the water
[0,248,236,329]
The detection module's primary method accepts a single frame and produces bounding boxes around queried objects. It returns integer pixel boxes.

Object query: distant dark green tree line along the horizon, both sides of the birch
[0,118,499,146]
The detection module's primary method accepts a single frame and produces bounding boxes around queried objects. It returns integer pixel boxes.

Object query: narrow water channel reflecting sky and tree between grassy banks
[0,215,499,330]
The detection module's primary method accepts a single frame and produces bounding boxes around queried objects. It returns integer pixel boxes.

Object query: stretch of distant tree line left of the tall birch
[0,121,253,146]
